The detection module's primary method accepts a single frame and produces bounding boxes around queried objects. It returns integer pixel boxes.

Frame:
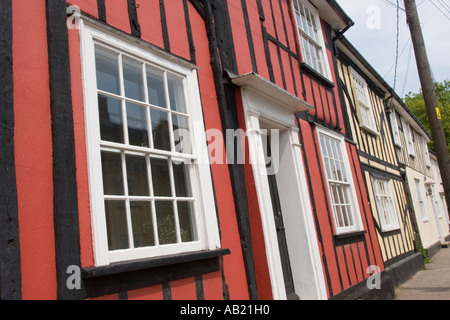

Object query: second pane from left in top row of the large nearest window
[123,57,145,101]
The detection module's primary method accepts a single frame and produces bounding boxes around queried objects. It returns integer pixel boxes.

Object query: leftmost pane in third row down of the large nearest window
[102,151,124,195]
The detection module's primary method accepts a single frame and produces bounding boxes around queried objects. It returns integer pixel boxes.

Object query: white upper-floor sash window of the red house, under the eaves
[294,0,329,78]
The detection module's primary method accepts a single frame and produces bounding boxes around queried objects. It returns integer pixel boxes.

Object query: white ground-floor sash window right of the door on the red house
[319,130,361,234]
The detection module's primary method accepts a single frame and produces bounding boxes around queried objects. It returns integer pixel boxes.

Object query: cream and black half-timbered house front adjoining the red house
[338,39,416,272]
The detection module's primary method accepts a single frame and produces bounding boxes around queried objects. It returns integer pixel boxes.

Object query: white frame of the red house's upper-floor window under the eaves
[292,0,332,81]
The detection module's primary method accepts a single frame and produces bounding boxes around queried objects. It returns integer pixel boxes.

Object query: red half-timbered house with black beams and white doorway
[0,0,408,300]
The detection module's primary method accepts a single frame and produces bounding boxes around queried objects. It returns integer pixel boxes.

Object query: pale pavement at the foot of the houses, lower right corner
[395,248,450,300]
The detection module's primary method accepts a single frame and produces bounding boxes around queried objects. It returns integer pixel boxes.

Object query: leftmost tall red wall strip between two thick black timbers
[12,0,56,299]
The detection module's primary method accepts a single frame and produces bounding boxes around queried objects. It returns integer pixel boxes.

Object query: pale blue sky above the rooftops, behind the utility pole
[338,0,450,98]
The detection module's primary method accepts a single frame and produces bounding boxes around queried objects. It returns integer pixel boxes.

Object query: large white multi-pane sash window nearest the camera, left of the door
[83,26,219,265]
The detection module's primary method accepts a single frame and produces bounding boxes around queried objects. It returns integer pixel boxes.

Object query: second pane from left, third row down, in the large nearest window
[126,155,150,196]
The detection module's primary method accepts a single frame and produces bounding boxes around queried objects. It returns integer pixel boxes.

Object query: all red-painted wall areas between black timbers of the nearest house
[13,0,383,300]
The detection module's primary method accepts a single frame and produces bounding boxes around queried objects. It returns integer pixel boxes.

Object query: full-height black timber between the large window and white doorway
[205,0,257,300]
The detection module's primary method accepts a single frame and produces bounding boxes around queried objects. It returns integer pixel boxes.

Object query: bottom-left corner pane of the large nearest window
[105,201,129,251]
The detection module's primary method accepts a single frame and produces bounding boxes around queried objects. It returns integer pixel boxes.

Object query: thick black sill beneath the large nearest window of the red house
[82,249,231,298]
